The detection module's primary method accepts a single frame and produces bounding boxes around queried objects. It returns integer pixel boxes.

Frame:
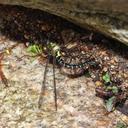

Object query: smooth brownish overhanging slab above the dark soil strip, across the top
[0,0,128,45]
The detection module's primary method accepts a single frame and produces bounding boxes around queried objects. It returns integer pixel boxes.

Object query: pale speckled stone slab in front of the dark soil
[0,36,128,128]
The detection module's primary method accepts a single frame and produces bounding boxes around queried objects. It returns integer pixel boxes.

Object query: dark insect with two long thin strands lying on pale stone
[29,40,99,111]
